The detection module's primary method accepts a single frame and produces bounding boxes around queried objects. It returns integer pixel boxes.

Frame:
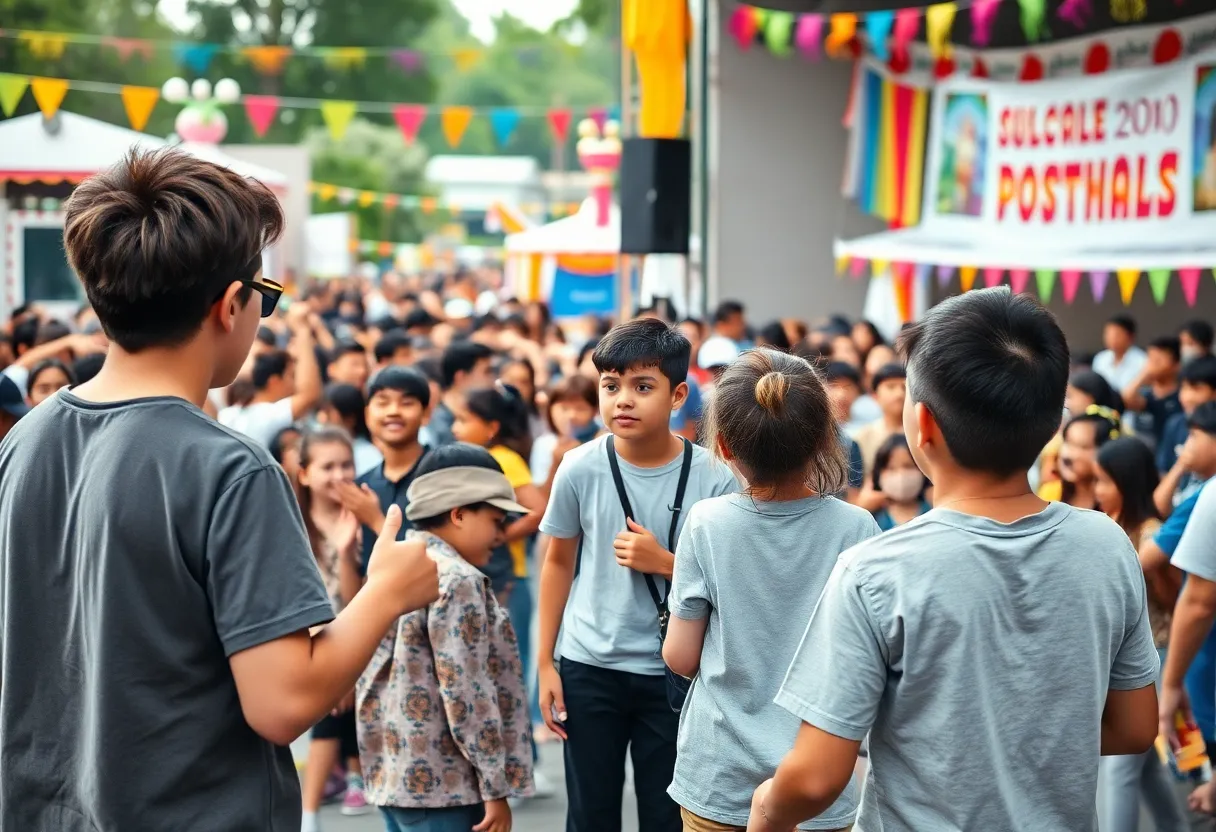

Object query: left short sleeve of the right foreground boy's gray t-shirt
[775,560,888,741]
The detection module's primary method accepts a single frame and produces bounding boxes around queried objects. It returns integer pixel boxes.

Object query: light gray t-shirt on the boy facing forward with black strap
[540,437,738,675]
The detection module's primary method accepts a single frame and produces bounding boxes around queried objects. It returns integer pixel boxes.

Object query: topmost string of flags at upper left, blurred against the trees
[0,29,588,75]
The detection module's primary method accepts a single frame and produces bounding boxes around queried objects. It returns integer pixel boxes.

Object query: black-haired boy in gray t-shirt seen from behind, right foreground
[748,288,1159,832]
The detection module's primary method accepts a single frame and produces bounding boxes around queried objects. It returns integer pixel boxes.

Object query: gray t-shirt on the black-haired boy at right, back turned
[777,502,1160,832]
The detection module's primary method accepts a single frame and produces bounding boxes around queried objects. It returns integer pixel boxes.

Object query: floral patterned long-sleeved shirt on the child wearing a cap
[355,532,533,809]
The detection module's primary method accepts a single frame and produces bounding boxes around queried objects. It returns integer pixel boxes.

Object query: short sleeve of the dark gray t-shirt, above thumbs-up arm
[206,466,333,656]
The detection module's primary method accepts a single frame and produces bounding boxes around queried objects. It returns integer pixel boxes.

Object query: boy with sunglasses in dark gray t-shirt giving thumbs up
[0,150,438,832]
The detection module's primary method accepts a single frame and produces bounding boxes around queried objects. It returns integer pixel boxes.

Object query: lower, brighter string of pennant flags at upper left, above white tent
[0,73,620,147]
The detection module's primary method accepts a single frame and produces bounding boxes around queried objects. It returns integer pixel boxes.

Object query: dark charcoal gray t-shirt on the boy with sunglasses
[0,392,333,832]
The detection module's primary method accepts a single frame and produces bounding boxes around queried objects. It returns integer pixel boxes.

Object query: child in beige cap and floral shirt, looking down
[355,443,533,832]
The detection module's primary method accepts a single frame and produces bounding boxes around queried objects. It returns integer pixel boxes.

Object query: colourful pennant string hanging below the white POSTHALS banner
[837,254,1216,313]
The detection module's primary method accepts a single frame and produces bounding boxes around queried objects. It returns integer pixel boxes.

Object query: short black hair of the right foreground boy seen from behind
[899,287,1069,477]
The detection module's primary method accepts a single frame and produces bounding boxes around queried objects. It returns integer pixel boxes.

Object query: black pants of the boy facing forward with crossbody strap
[562,659,683,832]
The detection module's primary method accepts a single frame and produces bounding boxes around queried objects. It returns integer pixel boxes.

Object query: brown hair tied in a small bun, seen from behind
[706,349,849,494]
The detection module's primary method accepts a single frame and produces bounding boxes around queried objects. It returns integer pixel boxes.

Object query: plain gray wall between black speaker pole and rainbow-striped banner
[709,6,883,324]
